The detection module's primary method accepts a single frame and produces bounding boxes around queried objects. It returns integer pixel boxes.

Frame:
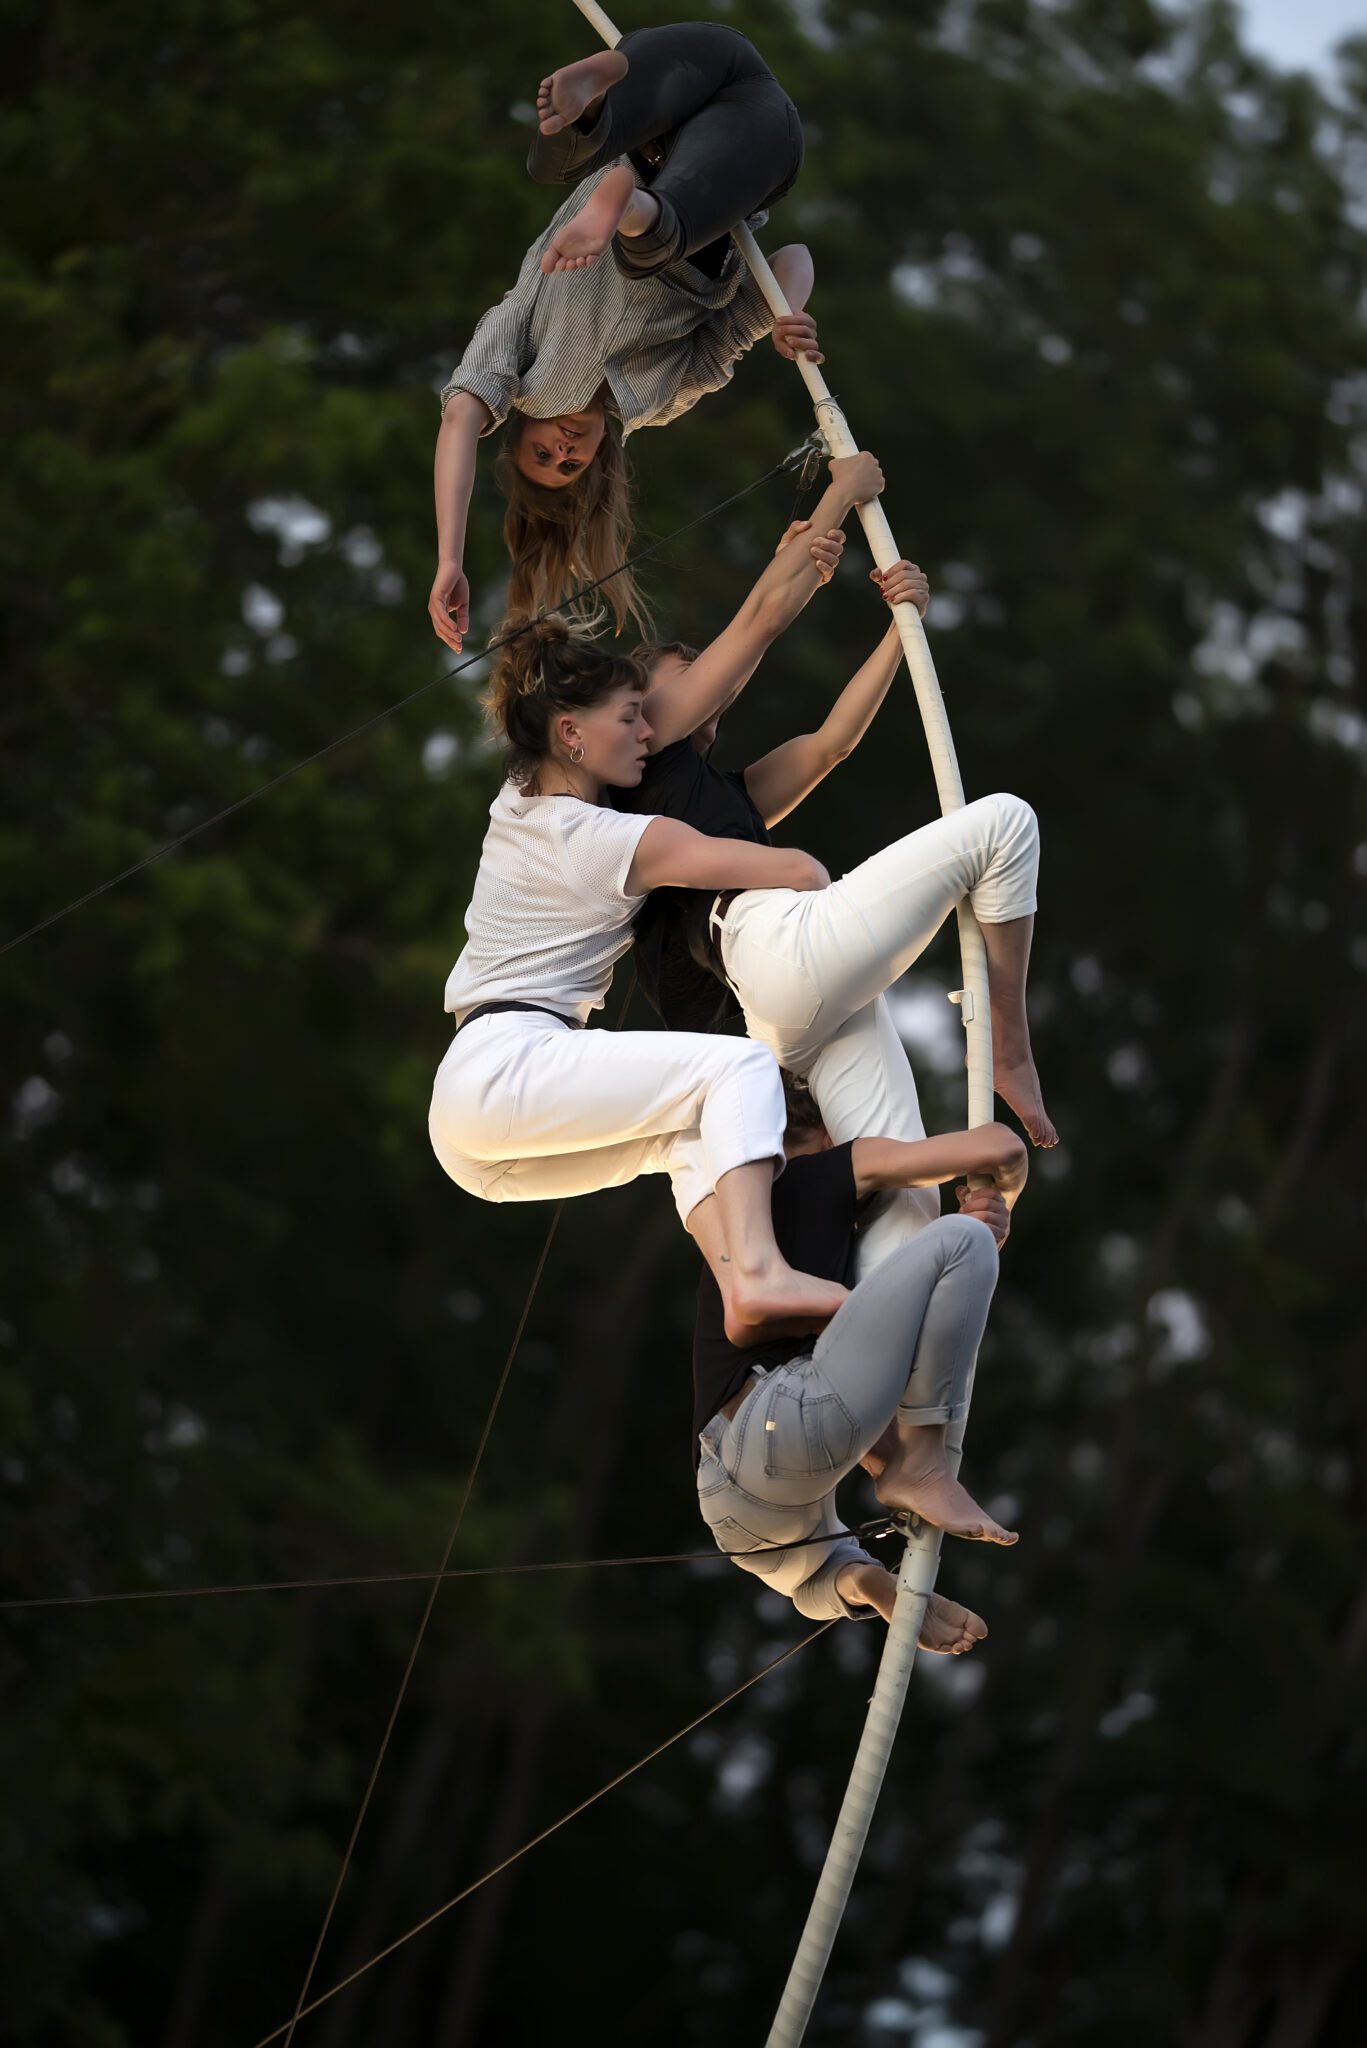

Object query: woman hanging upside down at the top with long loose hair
[428,23,822,653]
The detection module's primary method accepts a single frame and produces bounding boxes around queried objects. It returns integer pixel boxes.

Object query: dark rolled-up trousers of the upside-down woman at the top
[527,20,801,276]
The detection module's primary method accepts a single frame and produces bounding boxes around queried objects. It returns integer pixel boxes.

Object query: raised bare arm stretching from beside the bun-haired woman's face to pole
[646,455,883,752]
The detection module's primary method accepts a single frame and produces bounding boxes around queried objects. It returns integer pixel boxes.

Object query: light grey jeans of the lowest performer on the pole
[697,1217,996,1622]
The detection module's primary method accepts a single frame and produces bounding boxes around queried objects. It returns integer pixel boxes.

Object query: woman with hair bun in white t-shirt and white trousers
[428,616,844,1343]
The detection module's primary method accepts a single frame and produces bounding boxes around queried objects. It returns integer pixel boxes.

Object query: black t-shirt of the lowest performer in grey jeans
[693,1145,859,1462]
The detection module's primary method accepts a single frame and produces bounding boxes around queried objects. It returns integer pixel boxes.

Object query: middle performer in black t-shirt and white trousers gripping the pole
[611,457,1058,1272]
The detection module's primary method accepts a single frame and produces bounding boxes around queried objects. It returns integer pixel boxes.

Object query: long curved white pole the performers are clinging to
[574,12,992,2048]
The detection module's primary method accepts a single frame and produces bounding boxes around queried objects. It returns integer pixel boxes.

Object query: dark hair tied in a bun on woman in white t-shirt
[482,612,646,788]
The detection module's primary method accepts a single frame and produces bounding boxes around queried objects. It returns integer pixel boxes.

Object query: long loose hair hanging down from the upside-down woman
[494,412,654,635]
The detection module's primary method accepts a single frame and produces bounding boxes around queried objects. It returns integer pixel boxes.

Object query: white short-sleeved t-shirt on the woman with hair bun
[447,782,652,1024]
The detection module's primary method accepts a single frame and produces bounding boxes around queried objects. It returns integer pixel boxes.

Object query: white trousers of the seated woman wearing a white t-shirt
[428,1010,785,1223]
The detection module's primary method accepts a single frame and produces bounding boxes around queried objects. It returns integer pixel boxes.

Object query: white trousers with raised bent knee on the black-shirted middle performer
[717,795,1039,1278]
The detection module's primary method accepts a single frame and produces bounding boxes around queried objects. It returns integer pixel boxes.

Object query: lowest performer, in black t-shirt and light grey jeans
[693,1090,1027,1622]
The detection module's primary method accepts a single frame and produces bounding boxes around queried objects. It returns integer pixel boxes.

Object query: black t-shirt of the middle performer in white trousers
[609,739,771,1030]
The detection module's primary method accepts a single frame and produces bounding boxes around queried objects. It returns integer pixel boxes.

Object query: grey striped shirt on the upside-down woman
[441,158,773,434]
